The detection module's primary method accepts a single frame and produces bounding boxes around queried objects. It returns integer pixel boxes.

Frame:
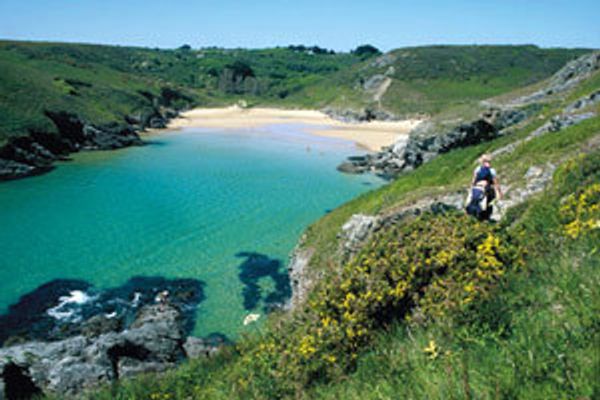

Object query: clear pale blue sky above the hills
[0,0,600,50]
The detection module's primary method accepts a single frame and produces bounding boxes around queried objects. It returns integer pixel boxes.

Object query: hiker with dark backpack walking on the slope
[466,154,502,221]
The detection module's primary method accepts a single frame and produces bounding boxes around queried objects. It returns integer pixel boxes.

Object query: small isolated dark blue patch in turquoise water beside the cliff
[235,251,291,312]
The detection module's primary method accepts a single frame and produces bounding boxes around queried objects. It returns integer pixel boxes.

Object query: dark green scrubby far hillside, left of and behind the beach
[0,42,360,144]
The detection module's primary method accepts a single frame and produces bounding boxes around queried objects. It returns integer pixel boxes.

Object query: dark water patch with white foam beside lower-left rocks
[0,276,205,346]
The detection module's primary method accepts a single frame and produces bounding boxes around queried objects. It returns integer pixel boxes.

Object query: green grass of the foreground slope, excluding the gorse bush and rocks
[79,62,600,399]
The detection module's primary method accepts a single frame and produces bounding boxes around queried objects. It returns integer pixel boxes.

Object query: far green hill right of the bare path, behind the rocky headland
[376,46,585,114]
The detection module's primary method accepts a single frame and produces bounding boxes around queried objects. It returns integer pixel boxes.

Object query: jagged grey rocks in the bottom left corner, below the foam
[0,304,185,398]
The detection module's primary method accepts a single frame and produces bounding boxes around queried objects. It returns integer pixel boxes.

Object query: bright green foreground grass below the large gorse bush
[84,150,600,399]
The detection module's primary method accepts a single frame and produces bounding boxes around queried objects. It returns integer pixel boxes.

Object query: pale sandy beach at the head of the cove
[167,106,420,151]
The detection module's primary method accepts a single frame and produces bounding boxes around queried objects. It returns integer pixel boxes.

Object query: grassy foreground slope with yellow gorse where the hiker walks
[81,54,600,399]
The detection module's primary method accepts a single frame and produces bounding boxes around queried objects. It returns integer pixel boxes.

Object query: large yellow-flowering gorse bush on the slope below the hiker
[232,213,519,392]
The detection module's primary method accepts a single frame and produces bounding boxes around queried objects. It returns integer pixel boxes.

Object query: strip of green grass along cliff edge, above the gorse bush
[305,95,600,270]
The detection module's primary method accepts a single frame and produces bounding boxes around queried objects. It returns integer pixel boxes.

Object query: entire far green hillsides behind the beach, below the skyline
[0,41,584,144]
